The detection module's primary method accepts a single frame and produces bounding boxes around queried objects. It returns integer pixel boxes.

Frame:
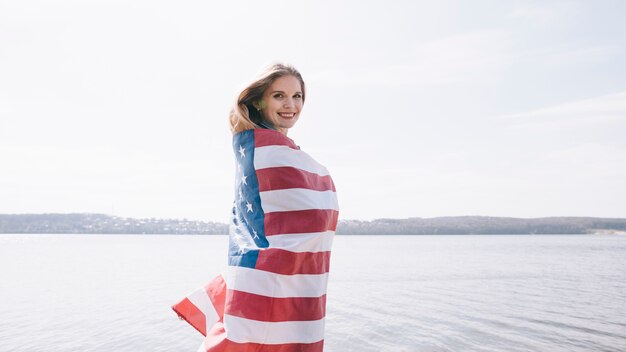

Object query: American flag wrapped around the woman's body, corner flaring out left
[172,129,338,352]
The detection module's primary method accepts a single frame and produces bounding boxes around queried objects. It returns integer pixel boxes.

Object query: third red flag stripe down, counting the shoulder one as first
[264,209,339,236]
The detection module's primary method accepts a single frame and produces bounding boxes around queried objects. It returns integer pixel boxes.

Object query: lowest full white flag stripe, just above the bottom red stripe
[224,314,324,344]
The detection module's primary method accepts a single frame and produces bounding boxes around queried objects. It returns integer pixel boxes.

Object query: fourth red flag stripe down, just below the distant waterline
[254,248,330,275]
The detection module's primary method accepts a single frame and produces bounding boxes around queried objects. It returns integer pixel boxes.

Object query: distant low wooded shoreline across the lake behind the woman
[0,213,626,236]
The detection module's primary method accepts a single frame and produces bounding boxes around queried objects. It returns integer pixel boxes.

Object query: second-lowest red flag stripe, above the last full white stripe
[226,290,326,322]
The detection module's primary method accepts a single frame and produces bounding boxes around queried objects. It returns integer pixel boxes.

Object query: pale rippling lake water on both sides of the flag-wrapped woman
[0,235,626,352]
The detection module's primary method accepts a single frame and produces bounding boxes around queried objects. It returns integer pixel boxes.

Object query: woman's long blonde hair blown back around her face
[229,63,305,134]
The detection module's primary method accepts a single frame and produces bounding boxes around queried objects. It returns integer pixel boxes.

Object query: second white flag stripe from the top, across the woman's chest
[260,188,339,214]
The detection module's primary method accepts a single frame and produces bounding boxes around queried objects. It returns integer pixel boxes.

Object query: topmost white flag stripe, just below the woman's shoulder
[254,145,328,176]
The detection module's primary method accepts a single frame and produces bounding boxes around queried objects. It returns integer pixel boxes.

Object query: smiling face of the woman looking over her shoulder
[259,76,303,129]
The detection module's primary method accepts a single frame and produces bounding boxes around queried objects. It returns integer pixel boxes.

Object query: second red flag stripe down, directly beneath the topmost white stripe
[256,167,335,192]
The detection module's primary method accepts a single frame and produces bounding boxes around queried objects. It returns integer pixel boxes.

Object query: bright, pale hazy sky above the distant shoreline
[0,0,626,222]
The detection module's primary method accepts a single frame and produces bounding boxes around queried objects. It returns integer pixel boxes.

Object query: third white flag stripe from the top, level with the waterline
[267,231,335,252]
